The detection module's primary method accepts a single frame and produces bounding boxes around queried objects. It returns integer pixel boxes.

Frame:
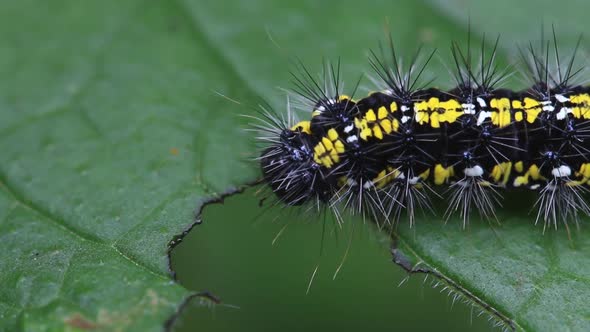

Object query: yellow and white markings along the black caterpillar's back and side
[308,89,590,188]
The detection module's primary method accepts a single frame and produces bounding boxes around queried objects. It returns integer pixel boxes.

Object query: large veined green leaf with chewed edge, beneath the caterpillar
[0,0,589,331]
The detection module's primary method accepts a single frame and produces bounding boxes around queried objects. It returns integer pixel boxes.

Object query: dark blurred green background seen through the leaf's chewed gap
[173,190,500,331]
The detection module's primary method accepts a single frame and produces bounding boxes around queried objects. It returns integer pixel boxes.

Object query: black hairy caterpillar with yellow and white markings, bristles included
[257,31,590,228]
